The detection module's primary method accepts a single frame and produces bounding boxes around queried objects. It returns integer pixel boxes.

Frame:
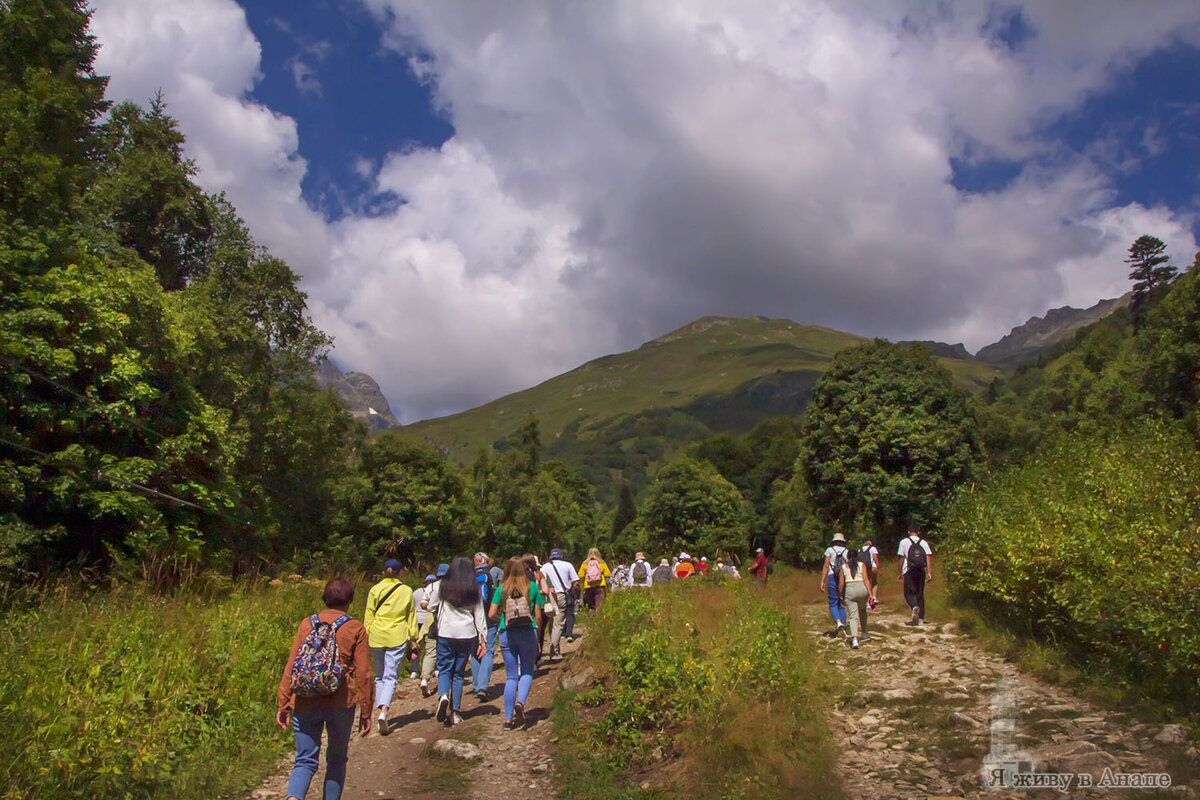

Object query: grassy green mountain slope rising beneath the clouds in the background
[388,317,1001,494]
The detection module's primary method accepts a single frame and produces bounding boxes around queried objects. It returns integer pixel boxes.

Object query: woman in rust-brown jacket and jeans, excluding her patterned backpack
[275,578,374,800]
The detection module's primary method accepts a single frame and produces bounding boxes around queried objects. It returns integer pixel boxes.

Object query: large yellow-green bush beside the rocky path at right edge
[943,422,1200,708]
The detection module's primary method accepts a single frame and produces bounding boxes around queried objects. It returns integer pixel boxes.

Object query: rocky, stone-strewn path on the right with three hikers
[802,602,1200,800]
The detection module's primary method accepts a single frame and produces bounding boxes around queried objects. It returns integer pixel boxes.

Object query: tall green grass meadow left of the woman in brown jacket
[0,582,366,800]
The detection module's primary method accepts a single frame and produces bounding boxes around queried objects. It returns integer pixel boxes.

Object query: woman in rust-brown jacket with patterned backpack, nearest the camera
[275,578,374,800]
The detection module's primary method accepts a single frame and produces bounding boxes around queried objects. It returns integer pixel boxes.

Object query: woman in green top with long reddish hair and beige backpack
[487,558,546,730]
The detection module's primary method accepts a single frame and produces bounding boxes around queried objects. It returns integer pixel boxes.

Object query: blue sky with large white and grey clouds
[92,0,1200,422]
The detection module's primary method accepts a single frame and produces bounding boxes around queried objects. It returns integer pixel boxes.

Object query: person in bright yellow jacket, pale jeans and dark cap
[362,559,419,736]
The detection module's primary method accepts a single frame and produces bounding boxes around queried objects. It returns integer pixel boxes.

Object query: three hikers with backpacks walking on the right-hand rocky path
[820,530,934,649]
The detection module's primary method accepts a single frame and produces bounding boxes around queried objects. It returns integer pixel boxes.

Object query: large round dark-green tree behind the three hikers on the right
[800,339,979,540]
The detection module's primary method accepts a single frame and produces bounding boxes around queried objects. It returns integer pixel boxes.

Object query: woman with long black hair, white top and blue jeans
[430,555,487,726]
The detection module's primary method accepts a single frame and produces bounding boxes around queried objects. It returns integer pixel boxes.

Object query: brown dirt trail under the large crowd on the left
[248,633,582,800]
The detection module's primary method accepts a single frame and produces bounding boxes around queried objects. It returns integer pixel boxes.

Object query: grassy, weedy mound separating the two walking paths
[556,579,841,800]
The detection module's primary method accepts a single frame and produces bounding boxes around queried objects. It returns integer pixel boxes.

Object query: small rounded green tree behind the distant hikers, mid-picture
[637,458,751,553]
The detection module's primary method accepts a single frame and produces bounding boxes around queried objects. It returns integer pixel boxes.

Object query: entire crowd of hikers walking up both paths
[276,531,934,800]
